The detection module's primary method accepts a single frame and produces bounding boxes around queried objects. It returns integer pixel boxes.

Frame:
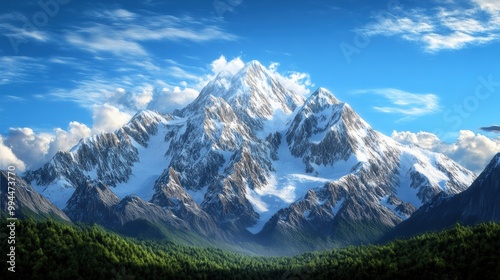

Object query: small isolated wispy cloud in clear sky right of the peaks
[354,88,439,117]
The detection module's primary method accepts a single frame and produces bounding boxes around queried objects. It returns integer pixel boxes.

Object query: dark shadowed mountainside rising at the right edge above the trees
[384,153,500,240]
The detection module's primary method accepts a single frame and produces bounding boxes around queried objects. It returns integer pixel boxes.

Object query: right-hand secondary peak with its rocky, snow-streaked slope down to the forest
[259,89,474,248]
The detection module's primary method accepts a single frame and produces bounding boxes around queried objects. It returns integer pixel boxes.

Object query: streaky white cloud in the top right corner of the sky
[357,0,500,53]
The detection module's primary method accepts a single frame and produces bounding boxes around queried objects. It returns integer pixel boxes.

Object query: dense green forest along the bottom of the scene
[0,220,500,279]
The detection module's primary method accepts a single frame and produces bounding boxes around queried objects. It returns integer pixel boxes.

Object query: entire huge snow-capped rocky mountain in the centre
[25,61,475,252]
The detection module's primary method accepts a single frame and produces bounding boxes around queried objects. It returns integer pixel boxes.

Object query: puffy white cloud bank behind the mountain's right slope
[391,130,500,174]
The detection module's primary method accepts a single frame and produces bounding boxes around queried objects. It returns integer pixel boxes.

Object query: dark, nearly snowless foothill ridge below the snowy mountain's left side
[64,181,225,239]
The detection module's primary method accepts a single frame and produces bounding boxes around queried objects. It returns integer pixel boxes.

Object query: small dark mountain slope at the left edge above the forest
[0,170,70,222]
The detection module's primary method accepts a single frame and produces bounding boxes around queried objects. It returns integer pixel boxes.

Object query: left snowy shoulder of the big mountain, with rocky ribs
[24,111,171,209]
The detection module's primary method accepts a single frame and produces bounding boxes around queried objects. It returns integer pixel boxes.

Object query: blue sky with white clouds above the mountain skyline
[0,0,500,172]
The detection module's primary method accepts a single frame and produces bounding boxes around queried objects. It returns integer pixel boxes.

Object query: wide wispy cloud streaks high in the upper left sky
[64,9,237,56]
